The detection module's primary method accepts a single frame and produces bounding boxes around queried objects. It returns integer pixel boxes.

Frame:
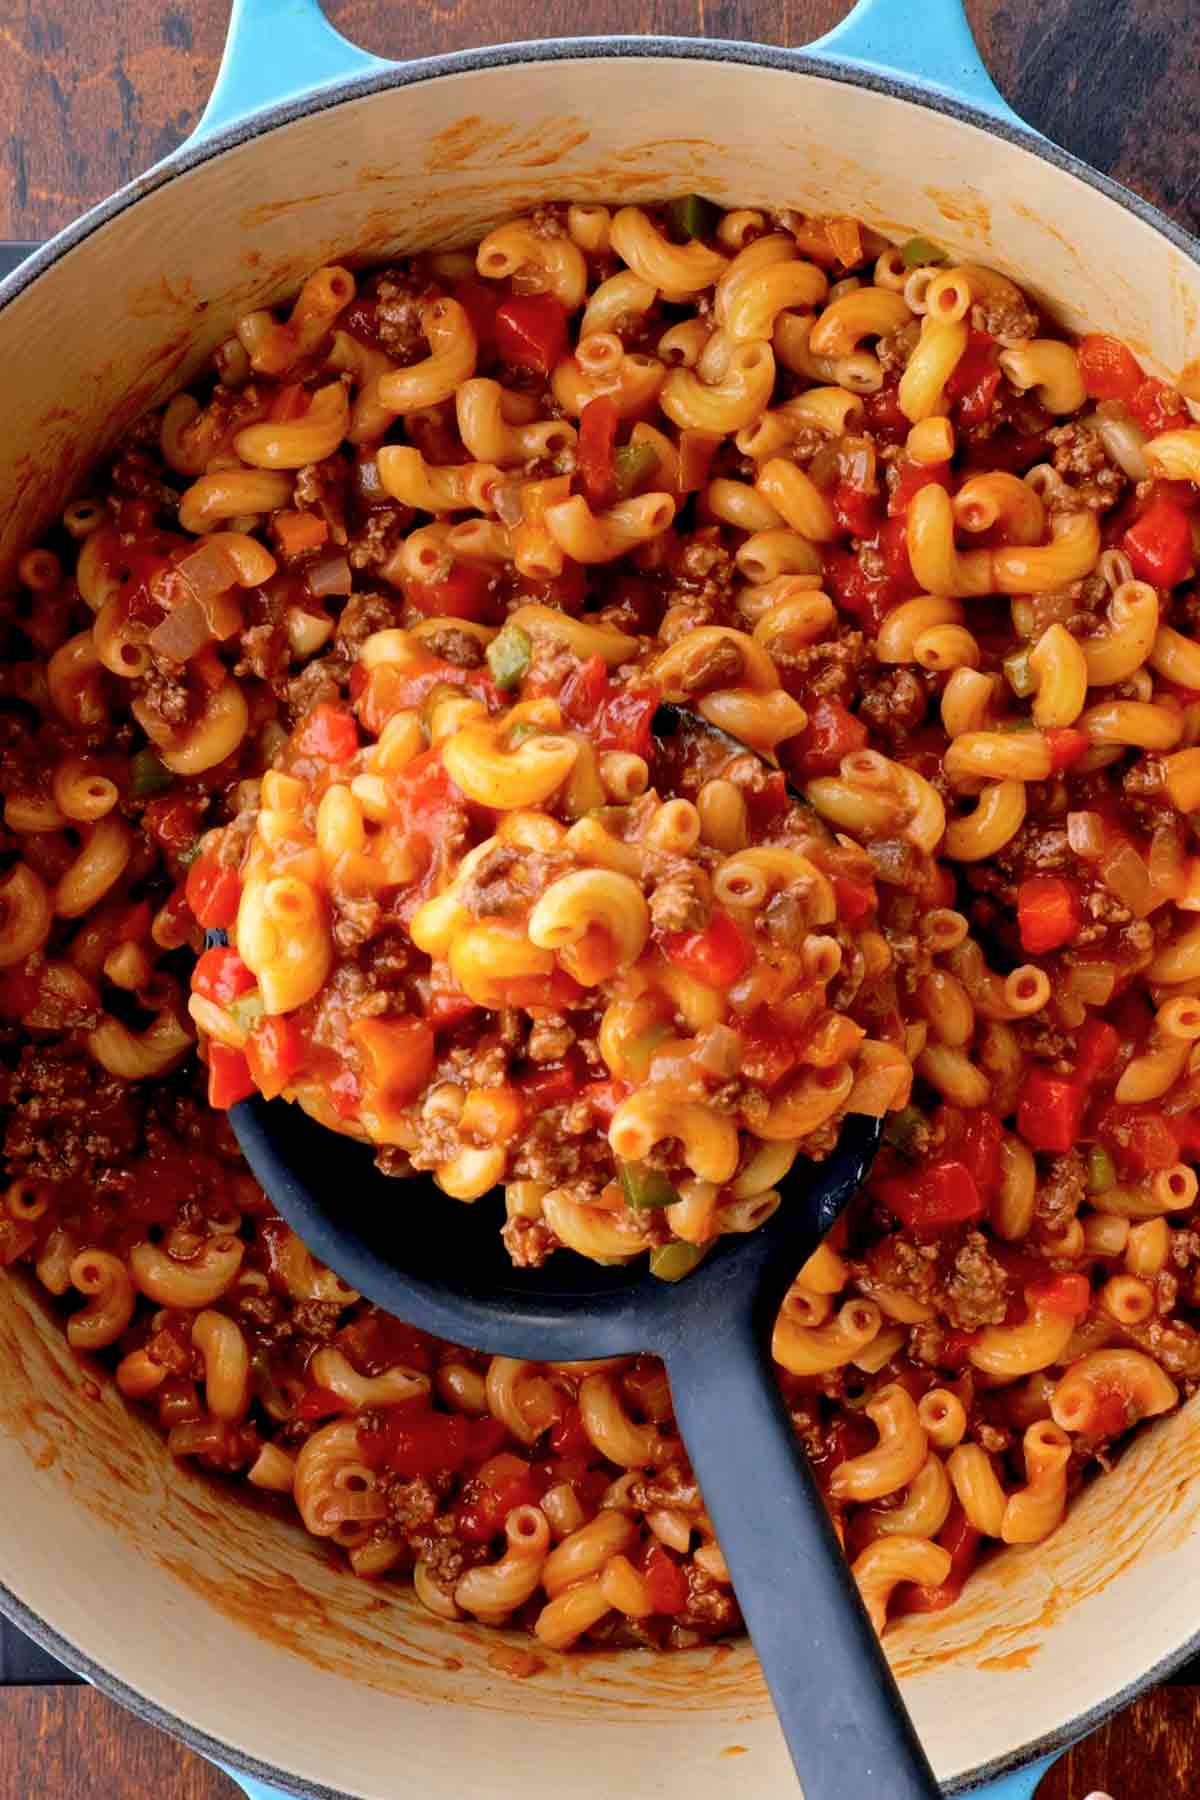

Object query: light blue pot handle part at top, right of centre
[808,0,1031,131]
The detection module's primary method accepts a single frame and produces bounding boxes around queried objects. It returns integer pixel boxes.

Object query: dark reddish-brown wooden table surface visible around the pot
[0,0,1200,1800]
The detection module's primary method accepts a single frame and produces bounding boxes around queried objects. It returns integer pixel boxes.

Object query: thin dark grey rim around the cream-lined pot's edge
[0,34,1200,1800]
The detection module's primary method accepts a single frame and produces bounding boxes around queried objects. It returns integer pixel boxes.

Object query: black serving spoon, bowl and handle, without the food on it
[220,707,941,1800]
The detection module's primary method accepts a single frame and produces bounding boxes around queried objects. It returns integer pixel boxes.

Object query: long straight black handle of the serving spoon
[667,1309,941,1800]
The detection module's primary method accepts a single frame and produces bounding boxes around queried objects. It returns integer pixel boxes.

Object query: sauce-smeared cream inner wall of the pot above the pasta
[0,45,1200,1800]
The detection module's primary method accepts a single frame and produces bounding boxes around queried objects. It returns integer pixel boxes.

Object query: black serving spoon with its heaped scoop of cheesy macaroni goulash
[191,603,948,1800]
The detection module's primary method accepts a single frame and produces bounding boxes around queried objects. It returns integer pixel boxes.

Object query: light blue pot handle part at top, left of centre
[189,0,396,144]
